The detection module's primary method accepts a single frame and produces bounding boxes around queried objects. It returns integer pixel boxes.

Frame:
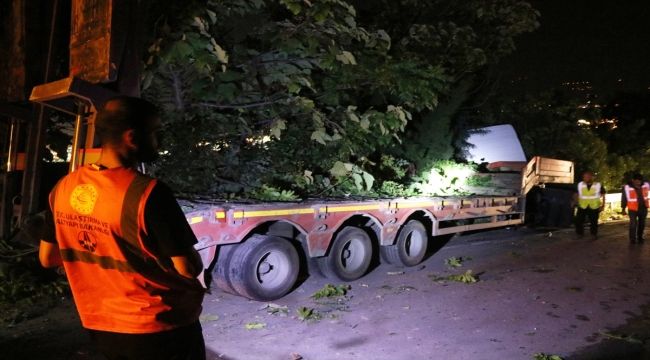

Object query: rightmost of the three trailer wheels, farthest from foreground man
[380,220,428,266]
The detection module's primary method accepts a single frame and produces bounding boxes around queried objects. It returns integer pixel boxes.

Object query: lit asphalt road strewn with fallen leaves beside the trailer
[0,224,650,360]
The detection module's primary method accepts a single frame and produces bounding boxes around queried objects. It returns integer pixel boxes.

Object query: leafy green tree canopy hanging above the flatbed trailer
[143,0,539,197]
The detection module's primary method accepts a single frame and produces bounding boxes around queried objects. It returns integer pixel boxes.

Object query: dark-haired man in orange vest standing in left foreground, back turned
[39,97,206,360]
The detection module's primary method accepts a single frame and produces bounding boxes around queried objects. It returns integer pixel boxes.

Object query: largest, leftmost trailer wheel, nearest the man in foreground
[229,235,300,301]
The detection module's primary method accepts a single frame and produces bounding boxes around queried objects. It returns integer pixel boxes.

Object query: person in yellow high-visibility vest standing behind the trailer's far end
[573,171,607,240]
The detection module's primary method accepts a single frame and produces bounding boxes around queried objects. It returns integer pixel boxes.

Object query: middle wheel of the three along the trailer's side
[318,227,372,281]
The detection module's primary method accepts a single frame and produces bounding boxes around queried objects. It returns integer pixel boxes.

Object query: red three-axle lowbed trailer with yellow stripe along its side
[181,157,573,301]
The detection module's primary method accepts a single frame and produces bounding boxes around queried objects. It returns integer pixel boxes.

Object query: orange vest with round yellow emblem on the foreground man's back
[50,165,204,334]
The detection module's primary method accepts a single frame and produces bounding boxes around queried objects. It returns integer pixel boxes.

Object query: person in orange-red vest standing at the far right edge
[621,174,650,244]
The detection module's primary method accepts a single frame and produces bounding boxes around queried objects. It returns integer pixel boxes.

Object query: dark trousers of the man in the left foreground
[88,321,205,360]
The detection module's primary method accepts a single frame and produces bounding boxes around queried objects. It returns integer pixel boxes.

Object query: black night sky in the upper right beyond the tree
[497,0,650,98]
